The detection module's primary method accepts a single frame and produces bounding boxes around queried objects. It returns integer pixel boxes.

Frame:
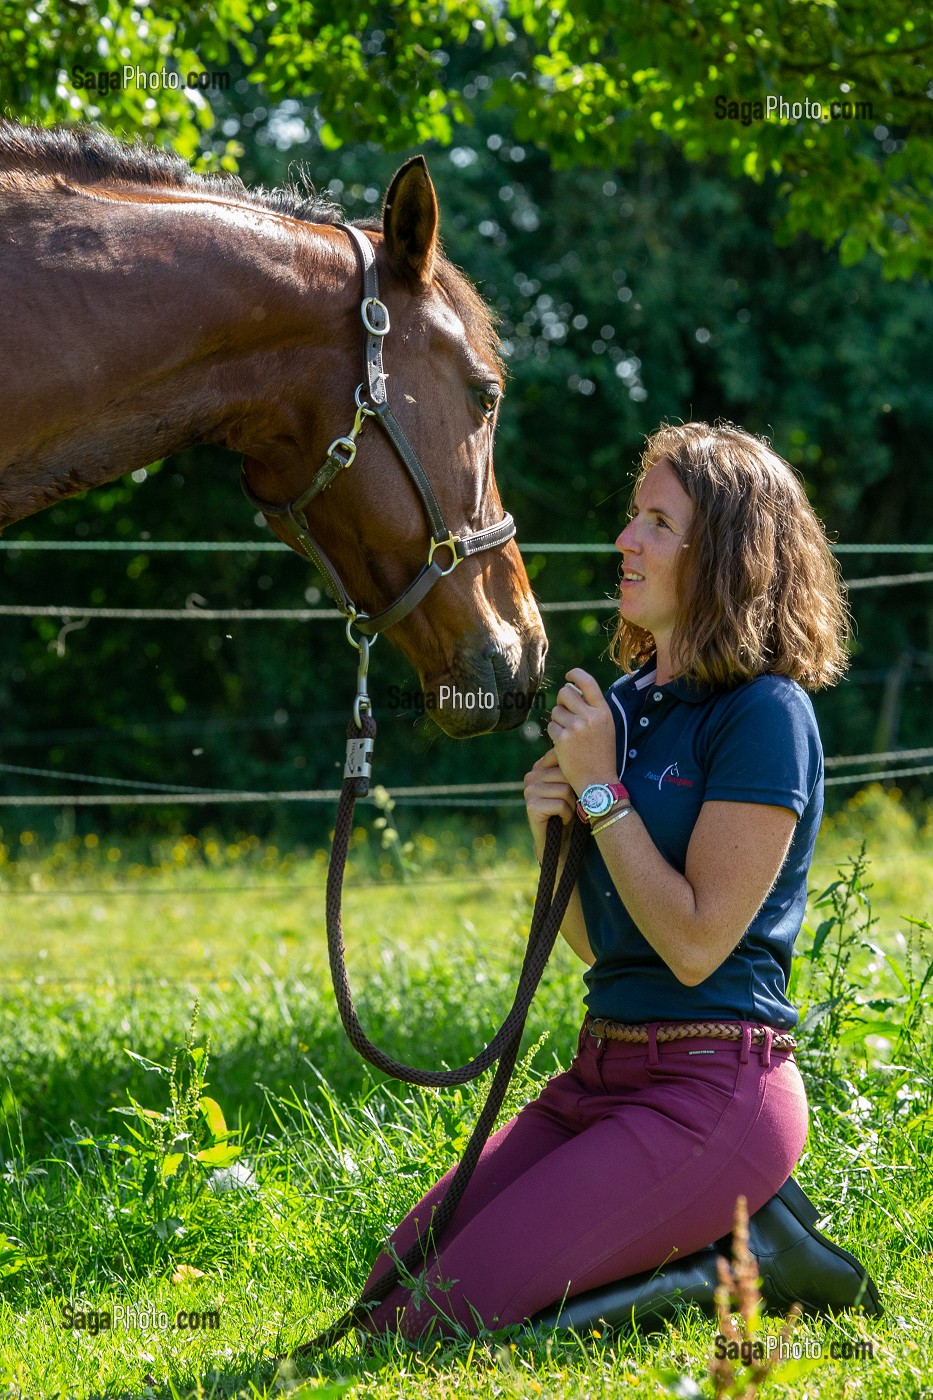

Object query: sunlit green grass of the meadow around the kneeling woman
[0,788,933,1400]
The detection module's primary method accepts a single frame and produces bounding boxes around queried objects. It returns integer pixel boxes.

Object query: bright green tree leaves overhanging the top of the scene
[0,0,933,277]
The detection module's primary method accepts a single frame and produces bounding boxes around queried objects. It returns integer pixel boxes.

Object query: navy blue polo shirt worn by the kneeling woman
[579,661,822,1030]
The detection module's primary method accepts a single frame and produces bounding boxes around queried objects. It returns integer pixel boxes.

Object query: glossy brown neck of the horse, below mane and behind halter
[0,188,360,525]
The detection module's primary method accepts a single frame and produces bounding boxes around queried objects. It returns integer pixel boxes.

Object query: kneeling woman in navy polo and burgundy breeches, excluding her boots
[370,423,862,1337]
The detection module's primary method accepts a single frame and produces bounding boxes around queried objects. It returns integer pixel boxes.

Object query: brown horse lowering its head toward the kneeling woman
[0,122,546,736]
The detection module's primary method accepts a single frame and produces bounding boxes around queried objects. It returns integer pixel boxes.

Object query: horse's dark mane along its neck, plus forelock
[0,118,503,372]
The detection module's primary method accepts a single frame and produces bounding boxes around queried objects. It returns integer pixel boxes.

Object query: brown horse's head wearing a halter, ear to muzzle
[244,157,546,736]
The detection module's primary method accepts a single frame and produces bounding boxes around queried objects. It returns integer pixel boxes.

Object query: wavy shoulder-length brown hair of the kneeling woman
[611,423,849,690]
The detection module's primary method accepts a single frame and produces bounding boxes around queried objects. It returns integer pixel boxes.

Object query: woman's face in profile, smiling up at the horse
[615,458,693,654]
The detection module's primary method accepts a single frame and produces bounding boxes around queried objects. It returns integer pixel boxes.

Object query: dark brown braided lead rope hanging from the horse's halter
[293,680,588,1357]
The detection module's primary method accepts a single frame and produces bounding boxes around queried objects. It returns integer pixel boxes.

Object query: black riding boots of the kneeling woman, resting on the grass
[531,1176,883,1331]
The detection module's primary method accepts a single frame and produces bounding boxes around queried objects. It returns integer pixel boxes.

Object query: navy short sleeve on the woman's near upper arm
[705,676,822,818]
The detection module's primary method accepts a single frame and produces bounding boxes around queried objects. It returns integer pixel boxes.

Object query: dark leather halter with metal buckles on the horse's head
[241,224,516,640]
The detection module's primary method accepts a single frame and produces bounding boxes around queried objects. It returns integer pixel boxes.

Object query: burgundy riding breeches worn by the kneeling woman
[355,1022,807,1338]
